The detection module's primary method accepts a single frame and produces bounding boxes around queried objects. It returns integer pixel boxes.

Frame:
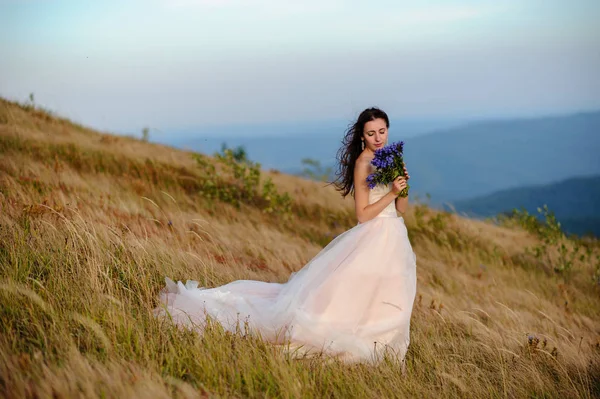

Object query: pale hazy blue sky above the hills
[0,0,600,131]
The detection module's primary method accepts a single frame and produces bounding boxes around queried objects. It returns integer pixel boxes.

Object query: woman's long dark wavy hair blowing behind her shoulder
[333,107,390,197]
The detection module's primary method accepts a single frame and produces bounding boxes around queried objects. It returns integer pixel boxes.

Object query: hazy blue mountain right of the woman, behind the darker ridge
[406,112,600,203]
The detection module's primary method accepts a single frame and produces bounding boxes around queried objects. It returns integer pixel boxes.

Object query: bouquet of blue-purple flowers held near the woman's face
[367,141,410,197]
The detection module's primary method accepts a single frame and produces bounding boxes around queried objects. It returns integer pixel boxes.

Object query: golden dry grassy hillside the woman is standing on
[0,97,600,398]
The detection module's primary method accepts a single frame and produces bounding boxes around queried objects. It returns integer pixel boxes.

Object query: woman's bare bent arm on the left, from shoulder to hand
[354,160,398,223]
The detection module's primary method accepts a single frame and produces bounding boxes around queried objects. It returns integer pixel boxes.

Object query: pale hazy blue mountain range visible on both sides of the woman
[170,111,600,205]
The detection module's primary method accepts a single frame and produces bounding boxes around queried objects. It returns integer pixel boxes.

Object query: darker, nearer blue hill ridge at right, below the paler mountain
[453,176,600,237]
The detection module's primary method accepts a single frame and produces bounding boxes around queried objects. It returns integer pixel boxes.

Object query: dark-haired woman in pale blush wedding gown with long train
[155,108,416,362]
